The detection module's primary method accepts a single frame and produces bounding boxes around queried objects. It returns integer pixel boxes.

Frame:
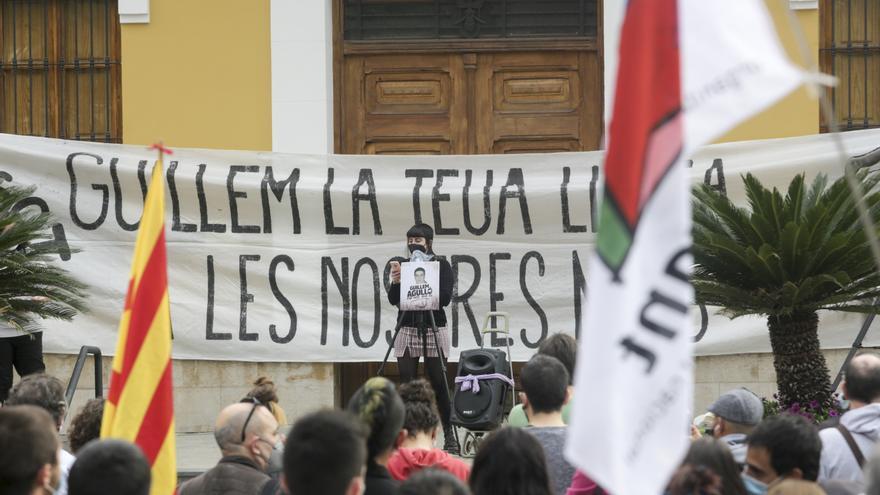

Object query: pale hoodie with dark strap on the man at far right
[819,404,880,481]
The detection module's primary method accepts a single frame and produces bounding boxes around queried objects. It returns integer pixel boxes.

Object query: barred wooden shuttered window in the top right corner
[819,0,880,131]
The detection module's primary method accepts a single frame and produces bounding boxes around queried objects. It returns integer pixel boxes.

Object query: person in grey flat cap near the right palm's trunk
[709,388,764,467]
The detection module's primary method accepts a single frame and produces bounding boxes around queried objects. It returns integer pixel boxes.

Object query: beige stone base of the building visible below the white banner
[34,349,868,432]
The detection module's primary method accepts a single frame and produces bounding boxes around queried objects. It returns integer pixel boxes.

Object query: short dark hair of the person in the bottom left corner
[0,405,61,495]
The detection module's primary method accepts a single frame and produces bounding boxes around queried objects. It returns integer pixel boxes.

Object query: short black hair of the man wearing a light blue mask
[748,414,822,481]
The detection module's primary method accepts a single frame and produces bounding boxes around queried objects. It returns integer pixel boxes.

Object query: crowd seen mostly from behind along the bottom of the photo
[0,340,880,495]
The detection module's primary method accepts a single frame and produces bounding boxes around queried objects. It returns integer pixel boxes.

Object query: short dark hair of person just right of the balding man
[284,411,367,495]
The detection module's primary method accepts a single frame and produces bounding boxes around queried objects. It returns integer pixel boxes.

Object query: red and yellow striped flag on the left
[101,157,177,495]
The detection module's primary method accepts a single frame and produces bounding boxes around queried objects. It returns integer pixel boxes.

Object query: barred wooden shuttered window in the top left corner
[0,0,122,143]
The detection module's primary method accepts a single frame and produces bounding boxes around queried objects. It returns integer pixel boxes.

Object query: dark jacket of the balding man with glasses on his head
[177,456,270,495]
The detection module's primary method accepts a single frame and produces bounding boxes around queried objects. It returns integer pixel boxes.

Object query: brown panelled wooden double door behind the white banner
[335,44,603,404]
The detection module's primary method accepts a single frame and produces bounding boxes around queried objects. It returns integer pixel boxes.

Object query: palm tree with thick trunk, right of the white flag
[693,169,880,406]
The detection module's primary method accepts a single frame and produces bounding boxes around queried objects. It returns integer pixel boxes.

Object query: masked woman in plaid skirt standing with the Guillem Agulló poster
[388,223,460,455]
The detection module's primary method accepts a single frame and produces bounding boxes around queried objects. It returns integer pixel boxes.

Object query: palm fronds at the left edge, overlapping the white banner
[0,185,85,332]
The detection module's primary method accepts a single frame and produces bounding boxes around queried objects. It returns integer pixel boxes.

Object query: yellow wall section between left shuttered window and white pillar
[121,0,272,151]
